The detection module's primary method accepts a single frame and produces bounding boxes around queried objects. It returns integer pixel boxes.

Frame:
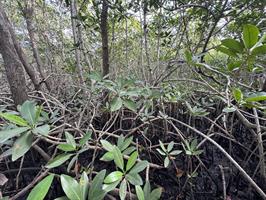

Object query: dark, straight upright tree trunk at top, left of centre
[101,0,109,76]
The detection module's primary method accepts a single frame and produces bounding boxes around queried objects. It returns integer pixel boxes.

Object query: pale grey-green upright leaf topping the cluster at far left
[20,101,36,125]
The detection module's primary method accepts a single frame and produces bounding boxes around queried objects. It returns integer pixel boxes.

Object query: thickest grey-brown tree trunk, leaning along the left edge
[0,3,28,105]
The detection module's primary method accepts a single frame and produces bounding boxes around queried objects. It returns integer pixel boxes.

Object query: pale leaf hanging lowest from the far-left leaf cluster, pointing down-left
[12,132,33,161]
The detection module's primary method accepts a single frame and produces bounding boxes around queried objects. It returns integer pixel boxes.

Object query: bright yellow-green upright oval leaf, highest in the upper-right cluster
[243,24,260,49]
